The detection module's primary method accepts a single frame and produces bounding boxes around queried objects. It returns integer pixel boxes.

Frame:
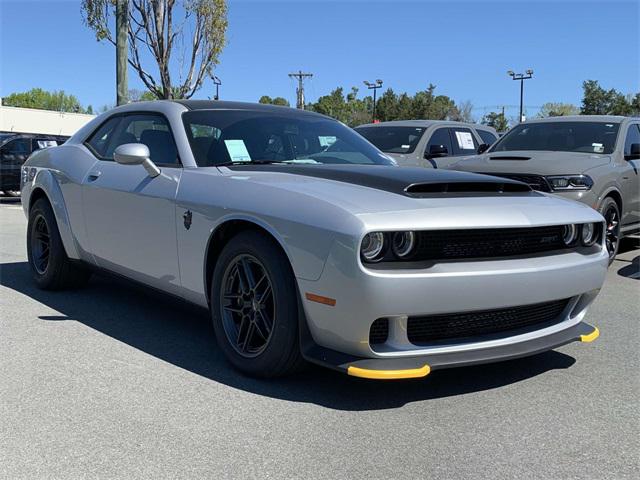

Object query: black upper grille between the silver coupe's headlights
[413,225,567,261]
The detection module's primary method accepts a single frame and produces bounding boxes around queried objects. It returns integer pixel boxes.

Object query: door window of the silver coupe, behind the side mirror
[105,113,179,166]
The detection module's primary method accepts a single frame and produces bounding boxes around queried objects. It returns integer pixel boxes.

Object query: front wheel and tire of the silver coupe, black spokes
[211,231,305,378]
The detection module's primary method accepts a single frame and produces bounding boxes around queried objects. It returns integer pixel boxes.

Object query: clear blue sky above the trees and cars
[0,0,640,118]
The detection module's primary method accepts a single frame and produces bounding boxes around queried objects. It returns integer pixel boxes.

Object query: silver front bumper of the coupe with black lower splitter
[298,236,608,376]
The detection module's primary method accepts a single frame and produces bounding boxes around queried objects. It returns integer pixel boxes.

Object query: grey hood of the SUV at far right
[451,150,611,175]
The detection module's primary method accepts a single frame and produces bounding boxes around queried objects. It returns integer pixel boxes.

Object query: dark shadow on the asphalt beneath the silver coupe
[0,262,575,411]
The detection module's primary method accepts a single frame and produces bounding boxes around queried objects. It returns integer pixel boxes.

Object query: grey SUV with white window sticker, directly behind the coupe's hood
[356,120,498,168]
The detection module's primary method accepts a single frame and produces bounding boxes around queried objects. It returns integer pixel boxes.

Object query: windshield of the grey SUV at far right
[491,122,620,154]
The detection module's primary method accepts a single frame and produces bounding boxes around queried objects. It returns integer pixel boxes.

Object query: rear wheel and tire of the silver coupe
[27,198,91,290]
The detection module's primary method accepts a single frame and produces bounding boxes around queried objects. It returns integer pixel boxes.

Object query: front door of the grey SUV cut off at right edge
[620,123,640,228]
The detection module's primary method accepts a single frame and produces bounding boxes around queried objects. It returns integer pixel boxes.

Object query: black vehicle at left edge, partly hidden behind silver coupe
[0,133,69,196]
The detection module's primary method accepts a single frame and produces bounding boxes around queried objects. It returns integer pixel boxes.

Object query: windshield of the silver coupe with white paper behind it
[182,110,393,167]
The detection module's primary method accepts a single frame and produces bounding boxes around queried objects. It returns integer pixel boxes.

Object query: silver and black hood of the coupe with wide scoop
[219,165,600,228]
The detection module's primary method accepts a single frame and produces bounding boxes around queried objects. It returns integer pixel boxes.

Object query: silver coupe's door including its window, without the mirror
[83,112,182,293]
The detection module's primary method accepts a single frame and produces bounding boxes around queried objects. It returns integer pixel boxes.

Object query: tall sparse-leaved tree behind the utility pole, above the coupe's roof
[82,0,227,98]
